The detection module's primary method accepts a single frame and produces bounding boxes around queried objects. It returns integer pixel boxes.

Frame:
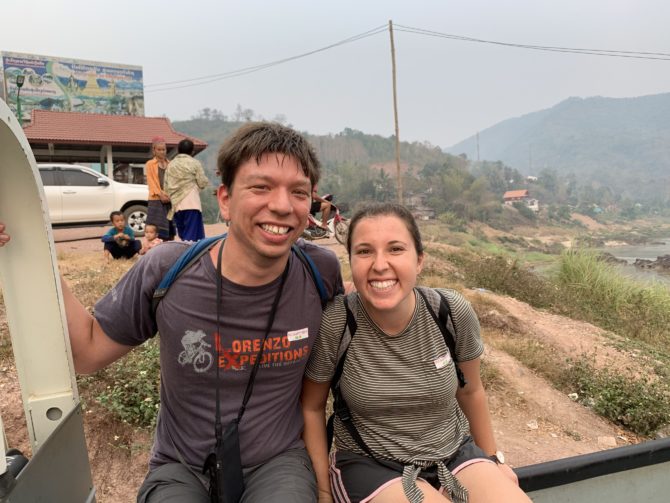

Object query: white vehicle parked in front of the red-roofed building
[38,164,148,237]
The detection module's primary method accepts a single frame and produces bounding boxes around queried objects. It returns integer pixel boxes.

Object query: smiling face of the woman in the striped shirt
[350,215,423,320]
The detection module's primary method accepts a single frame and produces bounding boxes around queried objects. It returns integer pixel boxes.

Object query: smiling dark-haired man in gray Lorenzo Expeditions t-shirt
[11,123,342,503]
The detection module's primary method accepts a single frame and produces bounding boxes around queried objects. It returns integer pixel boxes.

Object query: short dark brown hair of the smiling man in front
[216,122,321,188]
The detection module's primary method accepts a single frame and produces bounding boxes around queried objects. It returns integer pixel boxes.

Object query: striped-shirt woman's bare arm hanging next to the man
[301,378,332,503]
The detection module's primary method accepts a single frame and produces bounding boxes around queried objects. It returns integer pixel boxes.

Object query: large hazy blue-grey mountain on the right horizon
[448,93,670,199]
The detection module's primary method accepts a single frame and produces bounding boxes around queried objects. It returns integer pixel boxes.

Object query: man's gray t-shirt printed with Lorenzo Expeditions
[95,243,342,468]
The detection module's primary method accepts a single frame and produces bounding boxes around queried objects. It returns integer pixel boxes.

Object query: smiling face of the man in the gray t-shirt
[218,154,311,263]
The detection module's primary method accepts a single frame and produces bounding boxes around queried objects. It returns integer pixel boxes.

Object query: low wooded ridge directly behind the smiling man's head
[173,116,460,181]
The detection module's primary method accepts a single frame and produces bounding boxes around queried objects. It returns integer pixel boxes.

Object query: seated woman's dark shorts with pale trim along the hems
[330,436,493,503]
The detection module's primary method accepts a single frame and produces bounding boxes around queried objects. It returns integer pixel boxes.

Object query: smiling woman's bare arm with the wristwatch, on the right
[456,358,518,484]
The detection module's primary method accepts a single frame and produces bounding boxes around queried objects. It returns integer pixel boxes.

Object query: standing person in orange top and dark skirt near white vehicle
[145,137,176,241]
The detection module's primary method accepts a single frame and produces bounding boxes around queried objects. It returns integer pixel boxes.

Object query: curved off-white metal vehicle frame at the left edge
[0,97,79,451]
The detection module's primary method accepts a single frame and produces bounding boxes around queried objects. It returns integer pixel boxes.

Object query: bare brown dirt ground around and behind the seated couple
[0,225,638,503]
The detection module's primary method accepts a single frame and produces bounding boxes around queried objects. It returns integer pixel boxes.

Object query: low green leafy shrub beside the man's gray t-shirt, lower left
[95,338,160,427]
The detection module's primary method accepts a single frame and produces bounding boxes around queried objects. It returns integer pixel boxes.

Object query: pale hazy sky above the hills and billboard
[0,0,670,147]
